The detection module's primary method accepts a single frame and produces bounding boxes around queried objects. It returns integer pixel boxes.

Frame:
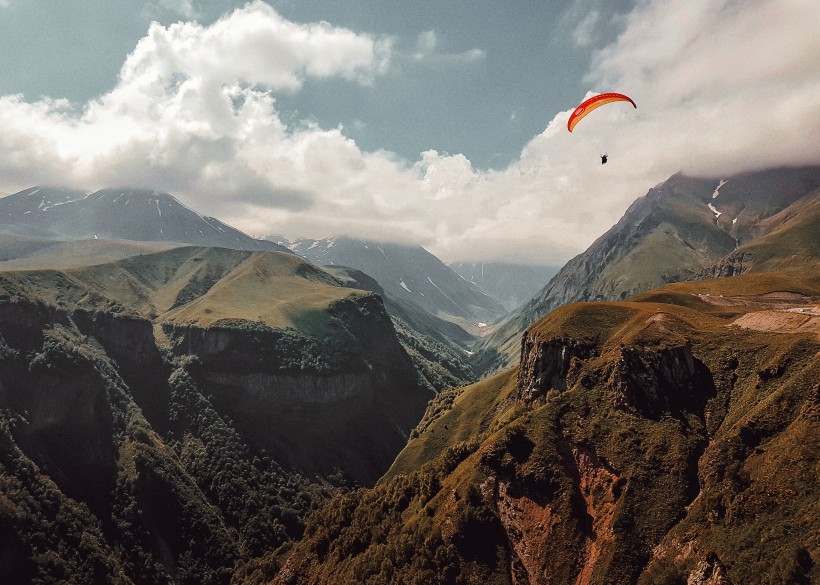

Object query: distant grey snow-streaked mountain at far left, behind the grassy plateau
[0,186,286,252]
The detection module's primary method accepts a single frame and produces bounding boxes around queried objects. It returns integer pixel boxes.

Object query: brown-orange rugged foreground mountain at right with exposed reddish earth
[272,273,820,585]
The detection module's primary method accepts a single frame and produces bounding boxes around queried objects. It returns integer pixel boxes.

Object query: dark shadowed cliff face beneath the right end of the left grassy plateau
[164,295,432,484]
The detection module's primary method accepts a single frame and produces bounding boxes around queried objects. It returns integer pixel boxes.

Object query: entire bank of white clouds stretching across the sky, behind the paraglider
[0,0,820,262]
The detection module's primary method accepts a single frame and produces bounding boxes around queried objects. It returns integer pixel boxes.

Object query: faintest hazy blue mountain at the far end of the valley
[449,262,560,311]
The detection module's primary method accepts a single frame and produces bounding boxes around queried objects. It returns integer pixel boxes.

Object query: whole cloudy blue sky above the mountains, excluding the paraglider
[0,0,820,264]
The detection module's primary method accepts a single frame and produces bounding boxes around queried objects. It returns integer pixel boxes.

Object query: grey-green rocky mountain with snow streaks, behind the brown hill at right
[476,167,820,371]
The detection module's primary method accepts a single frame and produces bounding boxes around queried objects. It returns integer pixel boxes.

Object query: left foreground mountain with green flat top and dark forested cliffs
[0,247,433,584]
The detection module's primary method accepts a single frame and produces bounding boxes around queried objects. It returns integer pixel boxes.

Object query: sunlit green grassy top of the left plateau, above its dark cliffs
[0,247,362,331]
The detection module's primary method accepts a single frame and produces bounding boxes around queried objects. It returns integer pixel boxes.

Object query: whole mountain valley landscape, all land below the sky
[0,167,820,585]
